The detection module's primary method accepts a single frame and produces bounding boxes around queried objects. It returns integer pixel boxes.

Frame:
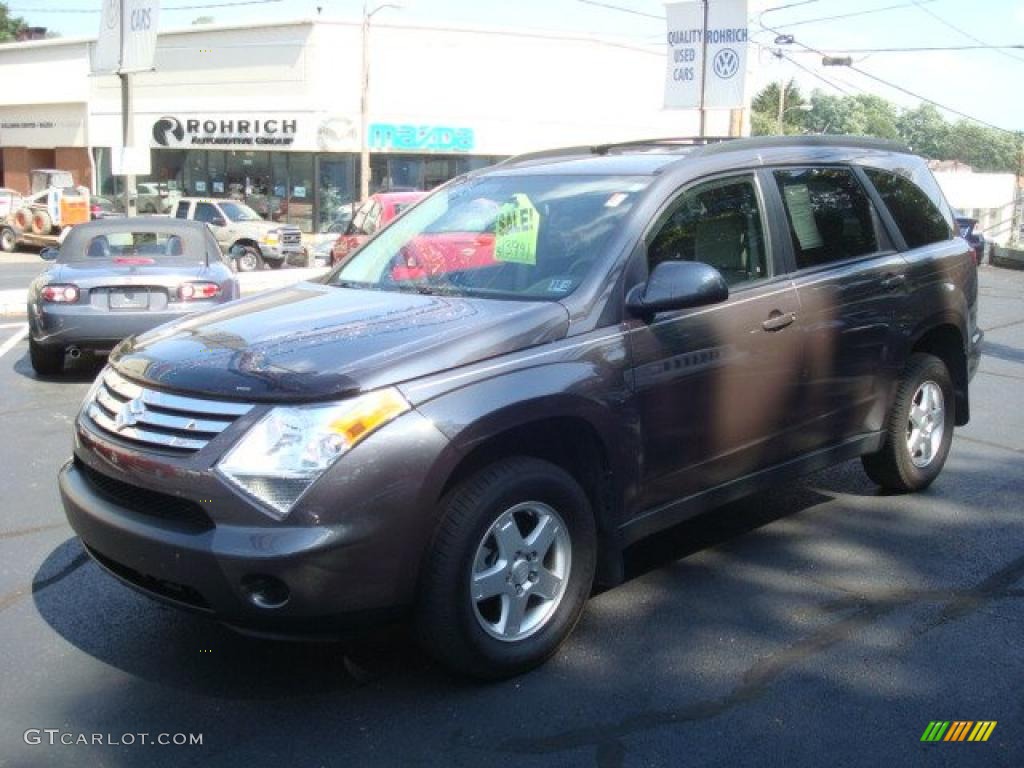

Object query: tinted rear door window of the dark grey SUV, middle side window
[775,168,879,269]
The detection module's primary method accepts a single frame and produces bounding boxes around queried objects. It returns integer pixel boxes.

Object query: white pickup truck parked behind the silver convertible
[174,198,306,272]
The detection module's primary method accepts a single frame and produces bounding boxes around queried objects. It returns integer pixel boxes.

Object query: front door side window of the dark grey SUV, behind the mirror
[647,178,768,286]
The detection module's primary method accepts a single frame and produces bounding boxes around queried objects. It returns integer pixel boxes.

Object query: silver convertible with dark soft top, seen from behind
[28,216,239,375]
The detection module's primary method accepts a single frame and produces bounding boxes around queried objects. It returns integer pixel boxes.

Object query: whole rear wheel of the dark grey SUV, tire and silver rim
[861,353,956,493]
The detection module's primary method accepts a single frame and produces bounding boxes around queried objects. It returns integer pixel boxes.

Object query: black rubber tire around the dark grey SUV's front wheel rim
[416,457,597,680]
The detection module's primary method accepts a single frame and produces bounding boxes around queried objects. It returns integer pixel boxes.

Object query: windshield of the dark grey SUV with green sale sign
[327,175,650,300]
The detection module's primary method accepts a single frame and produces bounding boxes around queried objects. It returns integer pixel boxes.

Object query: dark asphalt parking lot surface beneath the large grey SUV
[0,267,1024,768]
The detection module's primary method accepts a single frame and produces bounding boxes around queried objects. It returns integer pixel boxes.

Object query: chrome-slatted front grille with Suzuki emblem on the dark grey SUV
[85,368,252,454]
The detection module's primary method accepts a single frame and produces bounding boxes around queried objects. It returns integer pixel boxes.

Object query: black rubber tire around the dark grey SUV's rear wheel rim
[861,353,956,494]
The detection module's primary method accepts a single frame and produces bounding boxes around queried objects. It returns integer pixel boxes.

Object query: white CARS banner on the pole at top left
[92,0,160,75]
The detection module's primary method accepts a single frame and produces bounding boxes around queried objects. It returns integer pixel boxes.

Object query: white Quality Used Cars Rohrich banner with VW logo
[665,0,748,110]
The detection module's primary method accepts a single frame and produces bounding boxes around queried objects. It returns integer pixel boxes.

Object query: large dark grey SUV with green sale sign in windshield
[60,137,981,678]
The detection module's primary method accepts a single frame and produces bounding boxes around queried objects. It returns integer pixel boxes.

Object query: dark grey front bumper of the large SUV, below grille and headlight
[59,403,445,635]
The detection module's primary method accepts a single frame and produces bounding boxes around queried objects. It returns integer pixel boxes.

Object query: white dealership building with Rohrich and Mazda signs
[0,14,735,231]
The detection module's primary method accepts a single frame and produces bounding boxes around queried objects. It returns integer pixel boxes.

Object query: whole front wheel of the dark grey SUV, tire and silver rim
[417,458,597,680]
